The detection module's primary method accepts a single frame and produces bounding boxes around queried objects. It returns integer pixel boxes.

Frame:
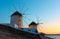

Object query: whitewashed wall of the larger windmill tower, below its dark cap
[10,15,23,28]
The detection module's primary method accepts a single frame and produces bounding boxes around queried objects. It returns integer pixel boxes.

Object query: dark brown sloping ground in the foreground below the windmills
[0,24,40,39]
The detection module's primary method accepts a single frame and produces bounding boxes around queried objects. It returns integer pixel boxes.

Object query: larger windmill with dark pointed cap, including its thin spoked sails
[9,0,34,28]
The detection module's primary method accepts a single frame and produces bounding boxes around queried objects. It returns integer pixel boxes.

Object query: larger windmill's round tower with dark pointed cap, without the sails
[10,11,23,28]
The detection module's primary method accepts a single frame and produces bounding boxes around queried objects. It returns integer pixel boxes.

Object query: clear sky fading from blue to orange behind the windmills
[0,0,60,34]
